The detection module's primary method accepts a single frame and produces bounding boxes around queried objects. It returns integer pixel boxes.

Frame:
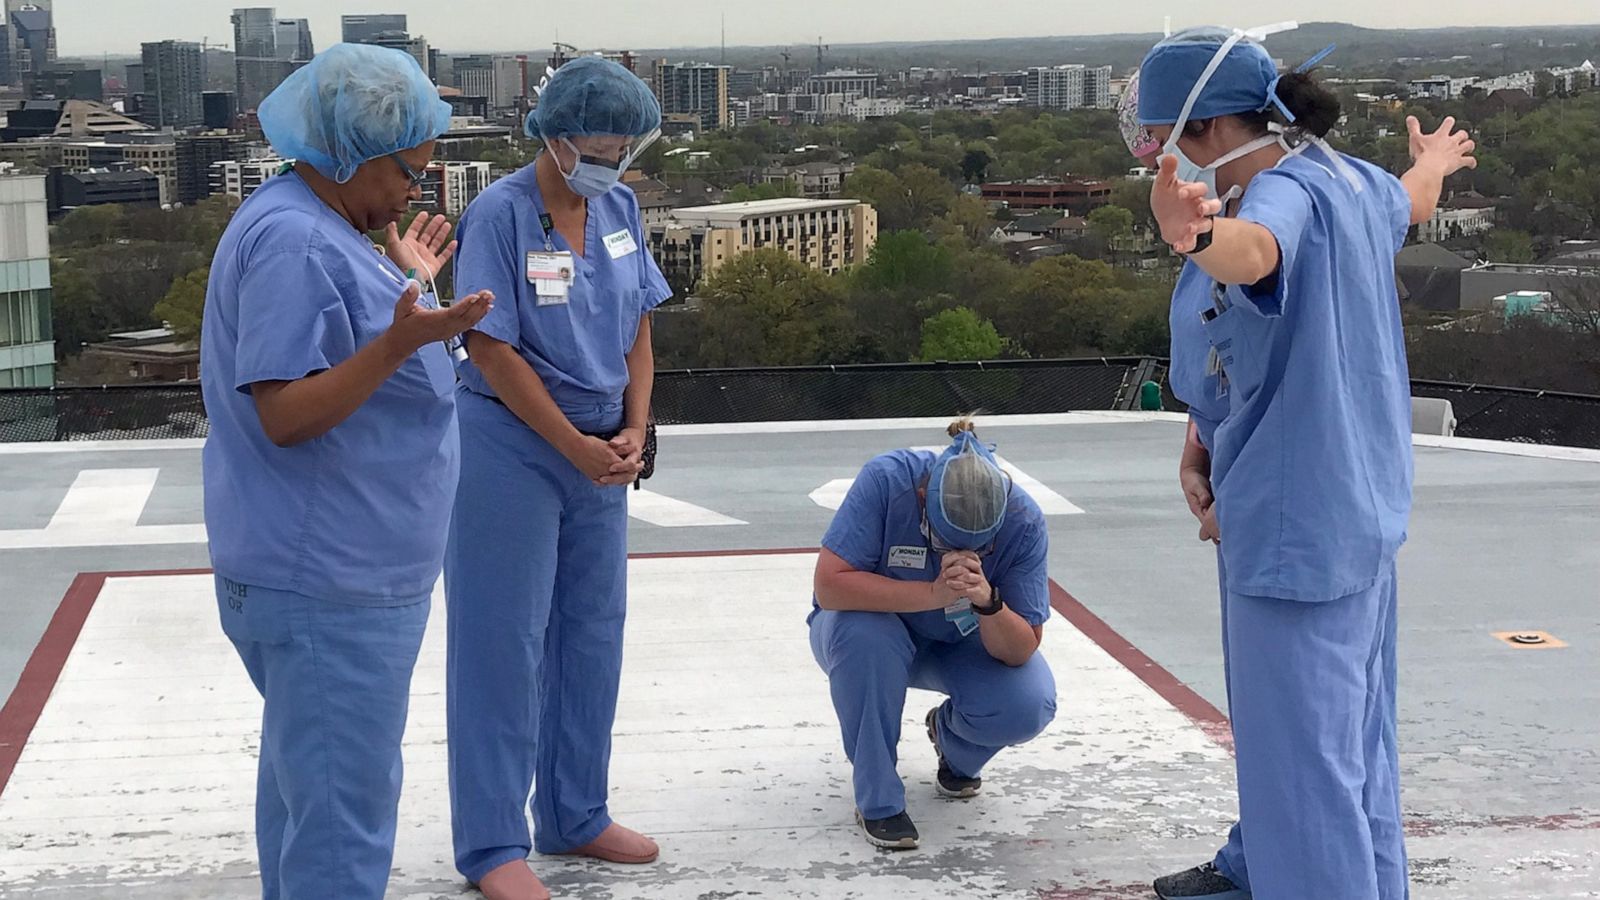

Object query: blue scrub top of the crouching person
[813,450,1050,630]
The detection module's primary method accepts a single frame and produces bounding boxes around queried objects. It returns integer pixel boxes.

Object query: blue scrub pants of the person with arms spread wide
[1216,556,1411,900]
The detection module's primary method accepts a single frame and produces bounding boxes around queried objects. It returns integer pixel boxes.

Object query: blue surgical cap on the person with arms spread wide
[1139,27,1278,125]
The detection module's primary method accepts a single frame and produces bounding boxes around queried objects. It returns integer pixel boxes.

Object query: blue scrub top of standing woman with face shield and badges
[456,165,672,429]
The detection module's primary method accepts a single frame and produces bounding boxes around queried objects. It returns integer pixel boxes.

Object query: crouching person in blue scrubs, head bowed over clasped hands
[810,420,1056,850]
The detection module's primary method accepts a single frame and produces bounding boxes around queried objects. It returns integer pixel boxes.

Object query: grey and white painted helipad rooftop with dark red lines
[0,413,1600,900]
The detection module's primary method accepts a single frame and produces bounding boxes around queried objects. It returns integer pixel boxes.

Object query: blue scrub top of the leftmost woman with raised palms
[200,173,459,605]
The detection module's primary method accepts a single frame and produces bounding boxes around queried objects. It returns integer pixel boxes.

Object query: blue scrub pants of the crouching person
[811,610,1056,818]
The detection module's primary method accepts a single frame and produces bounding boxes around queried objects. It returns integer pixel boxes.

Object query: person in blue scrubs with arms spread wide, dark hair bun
[1139,29,1474,900]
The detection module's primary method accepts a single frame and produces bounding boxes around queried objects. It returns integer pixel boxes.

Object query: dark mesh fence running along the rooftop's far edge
[0,357,1600,448]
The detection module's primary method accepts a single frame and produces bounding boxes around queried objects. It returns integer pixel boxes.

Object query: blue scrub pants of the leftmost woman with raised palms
[216,577,429,900]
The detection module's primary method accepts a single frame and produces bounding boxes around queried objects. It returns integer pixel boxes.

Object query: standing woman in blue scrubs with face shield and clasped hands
[445,56,670,900]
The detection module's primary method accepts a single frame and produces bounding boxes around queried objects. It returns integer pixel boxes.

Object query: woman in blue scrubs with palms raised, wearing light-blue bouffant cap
[200,45,491,900]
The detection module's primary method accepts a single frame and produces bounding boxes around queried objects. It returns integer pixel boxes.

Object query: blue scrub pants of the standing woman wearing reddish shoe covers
[445,391,627,882]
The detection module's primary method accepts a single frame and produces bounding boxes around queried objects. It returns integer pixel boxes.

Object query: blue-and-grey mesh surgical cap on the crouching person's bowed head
[928,431,1008,549]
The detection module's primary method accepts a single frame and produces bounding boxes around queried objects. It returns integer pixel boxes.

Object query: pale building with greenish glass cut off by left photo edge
[0,175,56,388]
